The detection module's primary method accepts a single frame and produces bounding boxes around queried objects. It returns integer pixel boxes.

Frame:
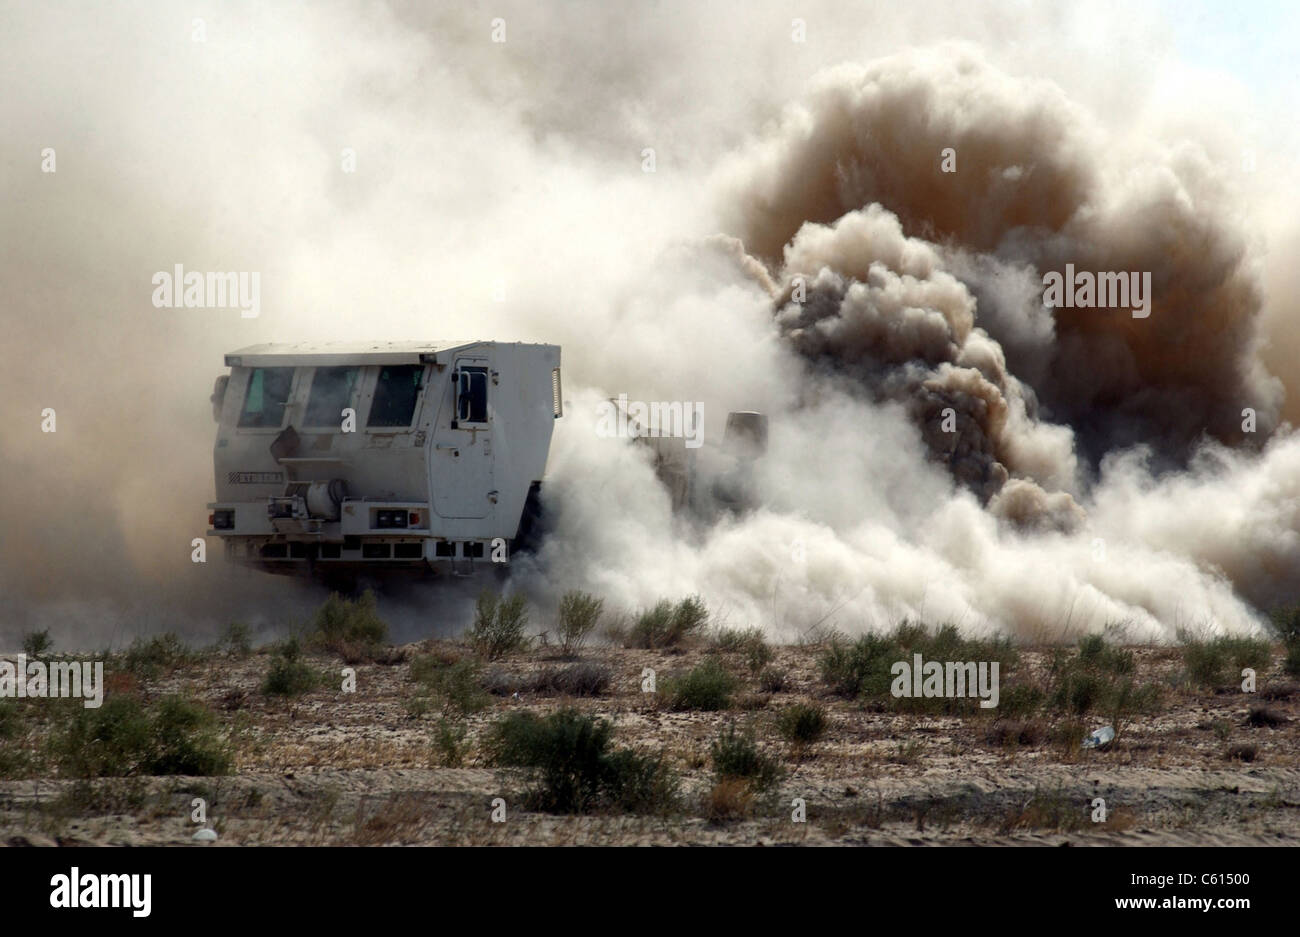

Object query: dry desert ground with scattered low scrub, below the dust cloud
[0,600,1300,847]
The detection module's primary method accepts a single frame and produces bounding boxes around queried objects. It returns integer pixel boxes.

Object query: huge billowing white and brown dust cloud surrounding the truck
[0,0,1300,646]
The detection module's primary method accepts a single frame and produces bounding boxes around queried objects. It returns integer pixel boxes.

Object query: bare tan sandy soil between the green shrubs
[0,642,1300,846]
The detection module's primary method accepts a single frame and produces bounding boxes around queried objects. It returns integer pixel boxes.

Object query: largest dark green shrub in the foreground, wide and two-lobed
[488,710,677,814]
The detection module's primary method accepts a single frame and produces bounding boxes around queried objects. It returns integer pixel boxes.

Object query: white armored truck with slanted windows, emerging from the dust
[208,342,562,584]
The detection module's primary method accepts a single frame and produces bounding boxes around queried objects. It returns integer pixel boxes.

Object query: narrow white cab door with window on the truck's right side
[432,356,497,517]
